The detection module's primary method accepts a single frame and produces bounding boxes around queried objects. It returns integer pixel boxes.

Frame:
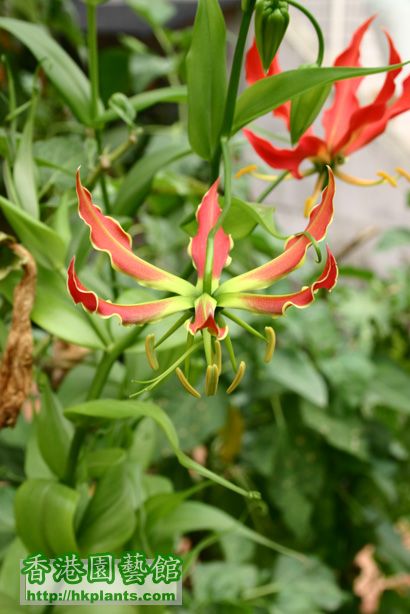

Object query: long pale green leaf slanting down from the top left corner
[0,17,92,125]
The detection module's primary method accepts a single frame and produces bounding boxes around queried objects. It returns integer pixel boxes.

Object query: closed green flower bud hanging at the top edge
[255,0,289,72]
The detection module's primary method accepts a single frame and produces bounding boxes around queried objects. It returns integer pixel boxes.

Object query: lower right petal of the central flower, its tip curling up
[218,247,338,316]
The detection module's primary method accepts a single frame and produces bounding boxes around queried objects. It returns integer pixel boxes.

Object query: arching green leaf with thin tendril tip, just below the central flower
[65,399,258,497]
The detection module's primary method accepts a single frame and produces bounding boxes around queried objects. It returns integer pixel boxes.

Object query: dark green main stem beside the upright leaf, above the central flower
[211,0,256,183]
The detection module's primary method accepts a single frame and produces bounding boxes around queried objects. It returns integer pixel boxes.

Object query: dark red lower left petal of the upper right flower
[243,130,330,179]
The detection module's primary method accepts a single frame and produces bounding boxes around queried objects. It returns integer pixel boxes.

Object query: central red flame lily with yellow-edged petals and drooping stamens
[68,170,337,397]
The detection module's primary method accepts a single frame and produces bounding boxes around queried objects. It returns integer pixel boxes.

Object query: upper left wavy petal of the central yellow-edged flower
[77,171,194,294]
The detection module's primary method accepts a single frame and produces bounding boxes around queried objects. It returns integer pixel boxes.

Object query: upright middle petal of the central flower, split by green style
[188,179,232,281]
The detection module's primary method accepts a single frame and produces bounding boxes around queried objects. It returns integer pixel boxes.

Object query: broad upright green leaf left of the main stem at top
[186,0,226,160]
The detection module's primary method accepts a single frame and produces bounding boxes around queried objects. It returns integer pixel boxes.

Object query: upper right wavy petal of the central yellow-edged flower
[217,169,335,294]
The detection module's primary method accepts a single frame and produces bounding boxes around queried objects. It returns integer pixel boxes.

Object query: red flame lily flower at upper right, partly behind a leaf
[244,17,410,215]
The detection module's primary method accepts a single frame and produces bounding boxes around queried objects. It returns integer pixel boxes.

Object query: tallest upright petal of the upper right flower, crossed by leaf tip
[322,16,375,151]
